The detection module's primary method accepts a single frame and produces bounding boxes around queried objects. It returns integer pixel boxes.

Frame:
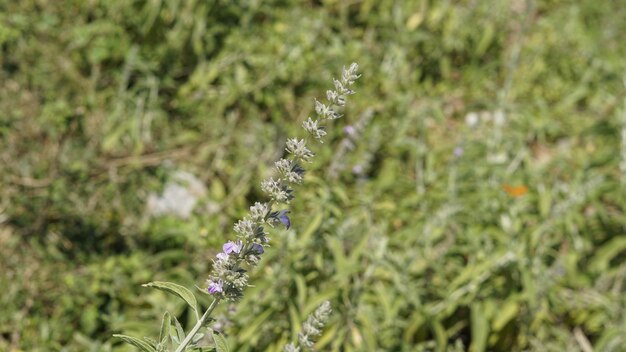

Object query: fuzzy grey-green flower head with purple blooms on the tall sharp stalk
[207,63,359,301]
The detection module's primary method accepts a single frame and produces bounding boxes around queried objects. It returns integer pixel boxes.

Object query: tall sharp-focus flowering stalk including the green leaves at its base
[114,63,360,352]
